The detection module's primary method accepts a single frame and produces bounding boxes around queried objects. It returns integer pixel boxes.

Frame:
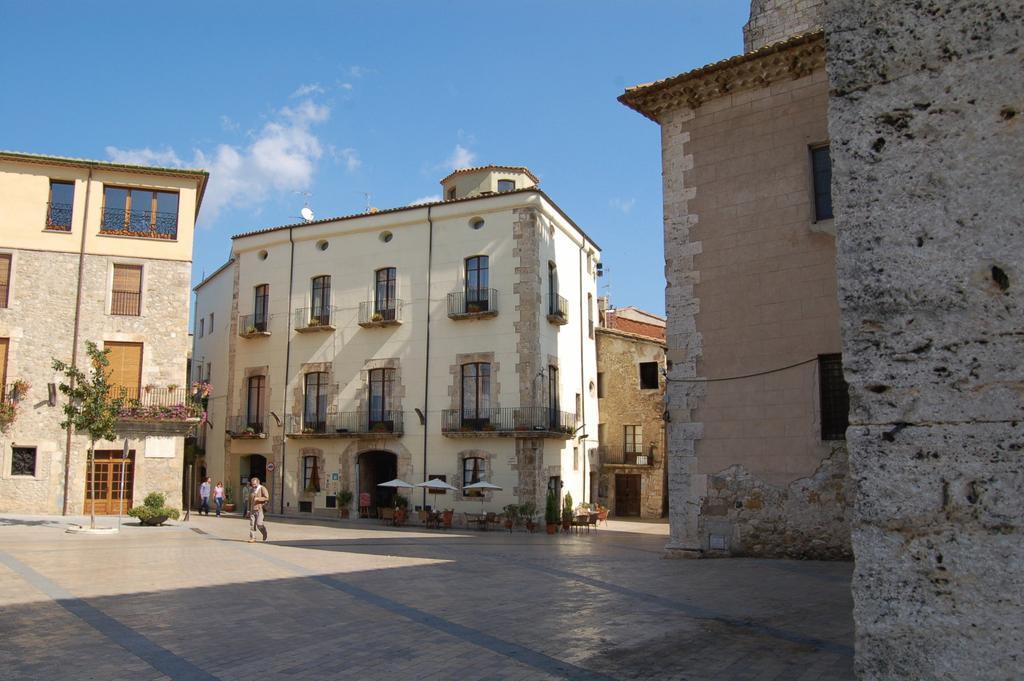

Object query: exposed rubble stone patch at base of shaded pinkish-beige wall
[699,444,853,560]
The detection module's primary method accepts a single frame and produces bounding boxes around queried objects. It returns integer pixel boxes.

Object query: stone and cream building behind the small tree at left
[0,152,208,513]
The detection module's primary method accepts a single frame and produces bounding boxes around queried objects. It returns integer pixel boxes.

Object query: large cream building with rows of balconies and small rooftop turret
[194,166,600,518]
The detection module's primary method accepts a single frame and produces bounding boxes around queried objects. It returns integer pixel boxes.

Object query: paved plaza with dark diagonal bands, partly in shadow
[0,515,853,681]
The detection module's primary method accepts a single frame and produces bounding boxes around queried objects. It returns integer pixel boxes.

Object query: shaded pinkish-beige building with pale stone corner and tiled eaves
[620,2,851,558]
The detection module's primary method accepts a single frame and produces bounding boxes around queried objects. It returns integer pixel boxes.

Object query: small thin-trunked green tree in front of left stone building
[53,341,124,529]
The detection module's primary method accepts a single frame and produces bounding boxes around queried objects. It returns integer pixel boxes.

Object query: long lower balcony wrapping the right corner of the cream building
[441,407,577,439]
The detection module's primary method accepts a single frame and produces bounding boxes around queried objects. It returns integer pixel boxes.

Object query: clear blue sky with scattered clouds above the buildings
[0,0,750,313]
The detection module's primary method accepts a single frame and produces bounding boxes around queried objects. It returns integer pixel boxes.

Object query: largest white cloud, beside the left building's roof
[106,99,331,223]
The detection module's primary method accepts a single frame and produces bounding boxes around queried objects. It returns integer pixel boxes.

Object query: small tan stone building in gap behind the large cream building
[592,322,668,519]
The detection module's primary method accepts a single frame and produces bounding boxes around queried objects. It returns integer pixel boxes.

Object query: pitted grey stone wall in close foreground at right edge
[826,0,1024,680]
